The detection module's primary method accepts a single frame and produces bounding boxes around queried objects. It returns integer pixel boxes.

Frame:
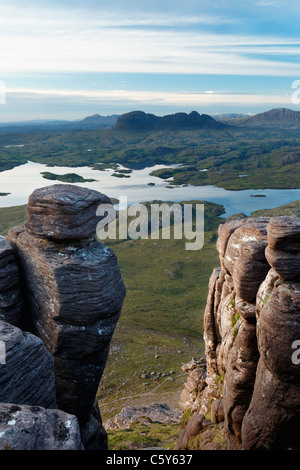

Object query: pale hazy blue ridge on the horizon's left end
[0,114,119,134]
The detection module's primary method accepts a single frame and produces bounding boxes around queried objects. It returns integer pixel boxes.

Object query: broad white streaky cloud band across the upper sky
[0,2,300,78]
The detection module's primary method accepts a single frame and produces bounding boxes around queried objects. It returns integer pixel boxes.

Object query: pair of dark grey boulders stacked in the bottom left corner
[0,320,84,450]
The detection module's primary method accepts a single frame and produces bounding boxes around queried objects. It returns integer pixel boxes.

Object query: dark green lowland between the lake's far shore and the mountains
[0,127,300,190]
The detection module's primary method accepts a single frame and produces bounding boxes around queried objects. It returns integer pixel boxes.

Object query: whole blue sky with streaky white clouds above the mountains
[0,0,300,122]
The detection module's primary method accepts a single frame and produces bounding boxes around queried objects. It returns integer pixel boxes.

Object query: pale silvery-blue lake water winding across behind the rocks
[0,162,300,216]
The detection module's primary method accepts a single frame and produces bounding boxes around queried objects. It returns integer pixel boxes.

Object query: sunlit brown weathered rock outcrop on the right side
[180,217,300,450]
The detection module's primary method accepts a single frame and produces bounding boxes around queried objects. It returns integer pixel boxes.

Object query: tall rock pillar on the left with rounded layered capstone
[0,184,125,449]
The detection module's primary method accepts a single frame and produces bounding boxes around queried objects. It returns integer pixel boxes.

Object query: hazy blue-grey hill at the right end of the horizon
[222,108,300,129]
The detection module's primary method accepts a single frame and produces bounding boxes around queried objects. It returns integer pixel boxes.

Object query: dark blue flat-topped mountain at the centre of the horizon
[113,111,225,132]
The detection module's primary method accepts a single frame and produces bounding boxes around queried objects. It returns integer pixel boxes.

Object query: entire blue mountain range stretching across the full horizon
[0,108,300,135]
